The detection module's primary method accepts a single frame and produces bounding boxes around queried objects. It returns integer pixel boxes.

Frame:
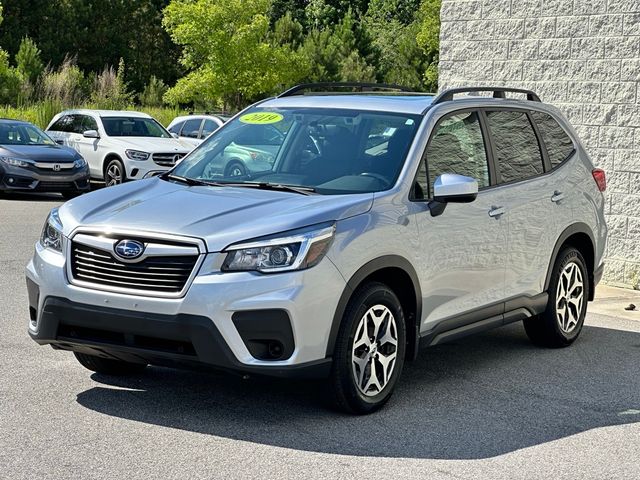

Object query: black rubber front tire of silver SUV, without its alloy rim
[334,283,406,413]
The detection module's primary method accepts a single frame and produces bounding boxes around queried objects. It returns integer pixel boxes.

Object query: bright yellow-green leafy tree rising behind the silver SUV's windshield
[163,0,305,109]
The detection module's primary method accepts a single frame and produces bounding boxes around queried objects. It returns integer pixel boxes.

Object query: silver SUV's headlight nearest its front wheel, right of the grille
[222,224,336,273]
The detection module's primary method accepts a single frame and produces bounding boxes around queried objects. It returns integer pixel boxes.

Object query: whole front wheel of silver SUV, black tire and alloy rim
[331,282,406,414]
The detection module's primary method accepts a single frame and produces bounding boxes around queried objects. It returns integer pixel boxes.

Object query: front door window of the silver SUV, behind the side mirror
[426,112,489,196]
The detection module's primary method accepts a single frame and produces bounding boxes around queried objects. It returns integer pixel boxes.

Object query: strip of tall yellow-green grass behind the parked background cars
[0,100,187,129]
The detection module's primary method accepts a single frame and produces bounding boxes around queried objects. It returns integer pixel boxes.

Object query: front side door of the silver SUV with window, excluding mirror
[416,110,507,333]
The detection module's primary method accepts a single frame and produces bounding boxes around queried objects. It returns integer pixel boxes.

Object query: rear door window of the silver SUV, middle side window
[487,111,544,183]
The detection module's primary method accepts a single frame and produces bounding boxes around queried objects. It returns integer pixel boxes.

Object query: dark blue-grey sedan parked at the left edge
[0,119,90,198]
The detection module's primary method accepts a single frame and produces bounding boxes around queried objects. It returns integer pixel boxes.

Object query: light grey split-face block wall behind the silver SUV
[439,0,640,286]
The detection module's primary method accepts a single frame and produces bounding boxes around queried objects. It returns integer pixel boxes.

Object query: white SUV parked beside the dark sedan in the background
[47,110,190,186]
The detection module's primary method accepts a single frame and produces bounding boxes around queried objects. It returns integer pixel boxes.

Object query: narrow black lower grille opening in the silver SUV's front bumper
[57,325,196,356]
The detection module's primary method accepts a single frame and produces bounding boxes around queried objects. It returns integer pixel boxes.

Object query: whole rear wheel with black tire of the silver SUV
[524,247,589,348]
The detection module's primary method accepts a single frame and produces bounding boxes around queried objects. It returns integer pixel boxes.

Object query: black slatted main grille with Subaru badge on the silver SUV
[71,241,198,294]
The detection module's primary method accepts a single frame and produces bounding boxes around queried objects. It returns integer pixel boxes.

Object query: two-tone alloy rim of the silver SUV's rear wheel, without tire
[556,262,584,333]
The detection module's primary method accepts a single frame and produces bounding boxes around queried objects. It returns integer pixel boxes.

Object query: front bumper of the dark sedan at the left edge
[0,165,90,192]
